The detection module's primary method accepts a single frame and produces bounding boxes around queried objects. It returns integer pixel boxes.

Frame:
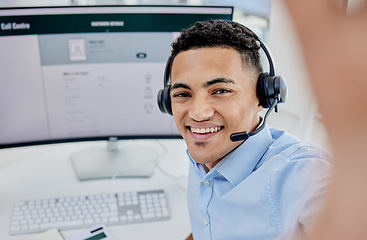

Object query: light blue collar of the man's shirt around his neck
[187,126,273,186]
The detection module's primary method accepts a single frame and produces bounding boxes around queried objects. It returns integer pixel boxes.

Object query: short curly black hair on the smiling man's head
[171,20,263,79]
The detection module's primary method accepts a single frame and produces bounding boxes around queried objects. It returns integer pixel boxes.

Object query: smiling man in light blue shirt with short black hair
[164,20,330,240]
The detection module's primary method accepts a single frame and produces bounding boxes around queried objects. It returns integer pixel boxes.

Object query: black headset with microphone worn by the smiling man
[157,20,288,142]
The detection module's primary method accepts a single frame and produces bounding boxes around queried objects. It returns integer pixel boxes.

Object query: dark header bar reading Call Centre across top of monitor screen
[0,6,233,36]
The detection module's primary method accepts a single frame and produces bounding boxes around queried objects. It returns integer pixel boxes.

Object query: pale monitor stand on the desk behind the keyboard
[71,138,159,180]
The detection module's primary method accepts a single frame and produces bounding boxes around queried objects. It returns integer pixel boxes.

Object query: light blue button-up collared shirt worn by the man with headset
[188,127,331,240]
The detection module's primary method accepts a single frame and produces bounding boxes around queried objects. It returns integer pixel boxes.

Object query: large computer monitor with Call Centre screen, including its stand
[0,5,233,179]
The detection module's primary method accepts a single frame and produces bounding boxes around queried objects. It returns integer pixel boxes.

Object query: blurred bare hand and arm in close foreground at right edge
[285,0,367,240]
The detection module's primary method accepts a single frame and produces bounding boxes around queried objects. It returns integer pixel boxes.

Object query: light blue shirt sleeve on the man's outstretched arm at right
[270,147,331,239]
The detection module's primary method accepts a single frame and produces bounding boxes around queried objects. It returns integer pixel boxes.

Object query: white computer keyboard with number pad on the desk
[10,190,170,234]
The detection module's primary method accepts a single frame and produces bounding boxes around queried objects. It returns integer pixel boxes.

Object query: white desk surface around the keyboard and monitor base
[0,140,191,240]
